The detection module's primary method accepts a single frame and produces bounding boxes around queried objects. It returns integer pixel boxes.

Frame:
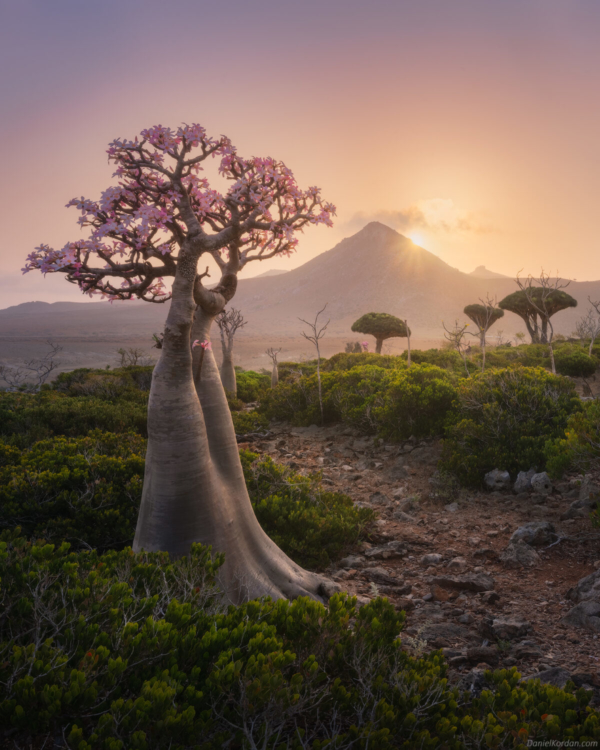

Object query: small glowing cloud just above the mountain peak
[347,198,493,234]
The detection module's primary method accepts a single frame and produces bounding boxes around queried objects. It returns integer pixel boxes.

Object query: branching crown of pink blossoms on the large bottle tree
[23,124,335,302]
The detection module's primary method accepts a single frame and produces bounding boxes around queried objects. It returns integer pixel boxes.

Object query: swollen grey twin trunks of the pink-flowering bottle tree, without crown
[133,258,328,603]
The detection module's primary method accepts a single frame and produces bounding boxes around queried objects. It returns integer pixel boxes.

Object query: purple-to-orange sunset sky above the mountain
[0,0,600,308]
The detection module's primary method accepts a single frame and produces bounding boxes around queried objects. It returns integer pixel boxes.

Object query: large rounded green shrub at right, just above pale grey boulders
[441,367,581,486]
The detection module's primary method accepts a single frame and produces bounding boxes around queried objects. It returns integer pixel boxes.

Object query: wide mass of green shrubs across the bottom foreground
[0,534,600,750]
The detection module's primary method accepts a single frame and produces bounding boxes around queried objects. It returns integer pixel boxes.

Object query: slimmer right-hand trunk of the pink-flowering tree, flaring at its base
[192,308,326,602]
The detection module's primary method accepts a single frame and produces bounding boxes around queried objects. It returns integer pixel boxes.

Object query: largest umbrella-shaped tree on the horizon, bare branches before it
[498,270,577,344]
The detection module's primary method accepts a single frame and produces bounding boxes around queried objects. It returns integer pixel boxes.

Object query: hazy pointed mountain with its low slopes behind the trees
[0,222,600,339]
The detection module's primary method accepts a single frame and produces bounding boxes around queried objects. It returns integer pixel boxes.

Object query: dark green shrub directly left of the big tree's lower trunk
[0,431,146,549]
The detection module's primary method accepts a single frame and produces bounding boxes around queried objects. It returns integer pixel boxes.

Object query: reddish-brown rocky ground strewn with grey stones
[238,424,600,698]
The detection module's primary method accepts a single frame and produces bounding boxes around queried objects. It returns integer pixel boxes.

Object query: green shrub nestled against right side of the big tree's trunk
[240,451,375,568]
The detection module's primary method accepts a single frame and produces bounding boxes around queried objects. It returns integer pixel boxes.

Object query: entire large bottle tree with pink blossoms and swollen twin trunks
[24,125,335,602]
